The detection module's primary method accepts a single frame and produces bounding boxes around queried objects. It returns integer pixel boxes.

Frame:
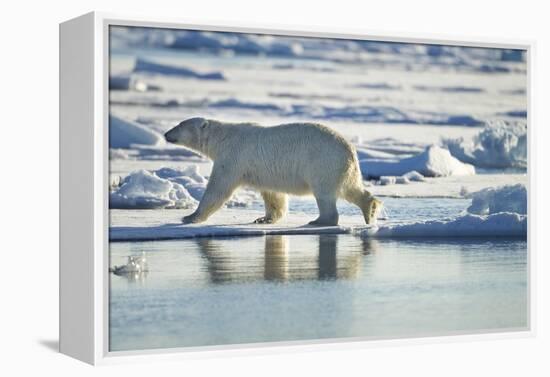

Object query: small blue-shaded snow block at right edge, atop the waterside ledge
[468,184,527,215]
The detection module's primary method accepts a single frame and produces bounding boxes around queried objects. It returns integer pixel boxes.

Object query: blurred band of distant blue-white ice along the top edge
[111,27,525,72]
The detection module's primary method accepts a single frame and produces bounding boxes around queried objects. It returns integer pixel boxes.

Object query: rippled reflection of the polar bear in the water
[195,235,377,283]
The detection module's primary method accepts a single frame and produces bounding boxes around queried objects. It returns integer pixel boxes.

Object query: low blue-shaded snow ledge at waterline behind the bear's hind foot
[362,212,527,238]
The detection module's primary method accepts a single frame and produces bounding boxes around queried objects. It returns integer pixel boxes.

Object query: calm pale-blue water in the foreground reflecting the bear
[110,235,527,351]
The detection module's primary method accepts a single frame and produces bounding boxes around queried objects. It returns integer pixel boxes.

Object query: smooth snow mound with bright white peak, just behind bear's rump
[359,145,475,178]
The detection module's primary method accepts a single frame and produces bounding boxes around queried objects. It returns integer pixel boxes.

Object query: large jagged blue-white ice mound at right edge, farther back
[443,120,527,168]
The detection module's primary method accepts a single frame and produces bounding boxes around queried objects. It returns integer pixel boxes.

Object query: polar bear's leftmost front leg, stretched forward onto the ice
[182,165,238,224]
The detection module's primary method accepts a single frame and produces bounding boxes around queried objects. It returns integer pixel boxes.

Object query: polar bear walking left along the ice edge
[164,118,381,225]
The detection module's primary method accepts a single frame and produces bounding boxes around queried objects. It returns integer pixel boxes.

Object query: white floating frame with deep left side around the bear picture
[59,12,536,364]
